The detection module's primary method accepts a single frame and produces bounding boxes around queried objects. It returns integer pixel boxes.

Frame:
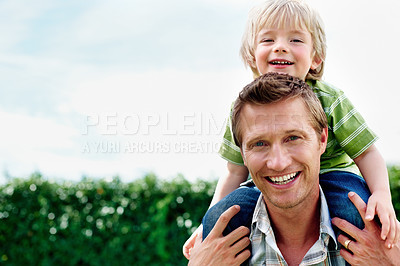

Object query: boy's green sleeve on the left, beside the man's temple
[218,107,244,165]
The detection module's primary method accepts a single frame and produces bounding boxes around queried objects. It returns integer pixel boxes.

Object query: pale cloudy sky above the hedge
[0,0,400,183]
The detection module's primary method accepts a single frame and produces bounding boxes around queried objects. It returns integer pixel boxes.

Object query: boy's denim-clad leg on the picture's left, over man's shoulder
[203,182,261,240]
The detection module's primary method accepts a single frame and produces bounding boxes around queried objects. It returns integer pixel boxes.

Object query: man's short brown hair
[232,73,328,148]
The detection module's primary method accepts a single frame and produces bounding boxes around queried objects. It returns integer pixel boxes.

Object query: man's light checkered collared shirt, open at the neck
[250,188,345,266]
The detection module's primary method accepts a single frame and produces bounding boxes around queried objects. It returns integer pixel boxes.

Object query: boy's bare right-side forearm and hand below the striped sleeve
[354,145,400,245]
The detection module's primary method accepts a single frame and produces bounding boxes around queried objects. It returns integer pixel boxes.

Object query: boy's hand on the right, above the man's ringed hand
[365,191,400,248]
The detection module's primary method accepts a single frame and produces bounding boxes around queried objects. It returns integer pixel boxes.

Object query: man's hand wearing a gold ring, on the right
[332,192,400,265]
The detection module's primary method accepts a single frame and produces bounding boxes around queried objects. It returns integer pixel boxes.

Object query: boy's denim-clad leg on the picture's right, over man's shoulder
[319,171,371,233]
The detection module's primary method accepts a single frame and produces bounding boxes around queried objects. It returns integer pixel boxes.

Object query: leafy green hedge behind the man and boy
[0,166,400,265]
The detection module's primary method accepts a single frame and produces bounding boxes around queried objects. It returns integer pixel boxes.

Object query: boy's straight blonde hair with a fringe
[240,0,326,80]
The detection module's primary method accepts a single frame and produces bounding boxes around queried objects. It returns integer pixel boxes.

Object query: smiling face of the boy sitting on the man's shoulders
[255,28,322,80]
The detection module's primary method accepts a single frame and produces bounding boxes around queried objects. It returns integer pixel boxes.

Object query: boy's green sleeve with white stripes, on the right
[328,91,378,159]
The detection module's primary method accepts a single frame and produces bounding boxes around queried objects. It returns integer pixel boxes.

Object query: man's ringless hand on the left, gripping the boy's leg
[188,205,250,266]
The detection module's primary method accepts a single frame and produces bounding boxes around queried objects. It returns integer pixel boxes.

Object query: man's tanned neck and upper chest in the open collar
[267,193,321,265]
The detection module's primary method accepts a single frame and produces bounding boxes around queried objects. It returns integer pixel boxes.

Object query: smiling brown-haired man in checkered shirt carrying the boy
[189,73,400,265]
